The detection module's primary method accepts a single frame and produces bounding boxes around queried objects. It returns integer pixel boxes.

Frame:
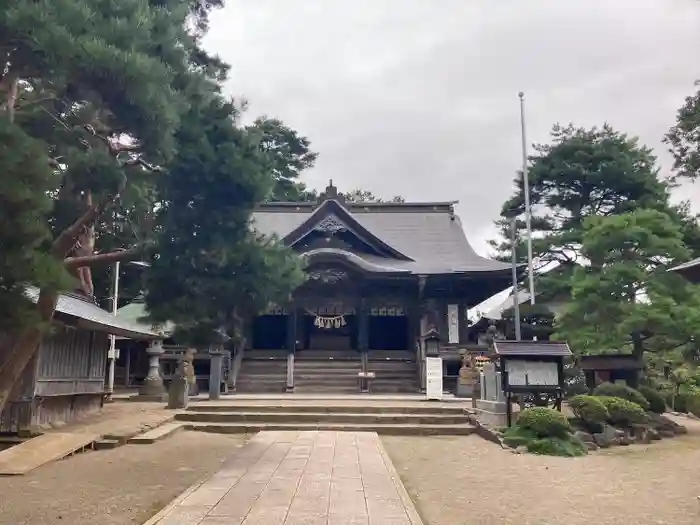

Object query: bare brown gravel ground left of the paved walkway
[0,432,246,525]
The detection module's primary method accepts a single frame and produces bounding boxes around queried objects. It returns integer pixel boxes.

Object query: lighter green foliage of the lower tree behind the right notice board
[555,208,700,356]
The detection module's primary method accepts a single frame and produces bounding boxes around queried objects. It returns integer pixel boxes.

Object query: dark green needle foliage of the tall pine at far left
[0,0,226,310]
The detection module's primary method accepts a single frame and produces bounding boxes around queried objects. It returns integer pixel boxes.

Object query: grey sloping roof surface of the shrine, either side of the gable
[253,203,510,274]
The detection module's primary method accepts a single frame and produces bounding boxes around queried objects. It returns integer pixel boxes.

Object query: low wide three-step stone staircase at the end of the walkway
[175,399,476,436]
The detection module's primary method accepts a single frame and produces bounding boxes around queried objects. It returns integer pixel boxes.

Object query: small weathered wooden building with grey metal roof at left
[0,288,160,433]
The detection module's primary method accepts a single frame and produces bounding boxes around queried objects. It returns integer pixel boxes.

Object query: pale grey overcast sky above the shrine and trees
[207,0,700,255]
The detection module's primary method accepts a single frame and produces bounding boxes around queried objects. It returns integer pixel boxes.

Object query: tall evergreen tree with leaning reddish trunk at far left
[0,0,226,411]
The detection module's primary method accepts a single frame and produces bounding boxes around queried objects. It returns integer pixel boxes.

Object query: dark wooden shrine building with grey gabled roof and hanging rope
[230,182,511,393]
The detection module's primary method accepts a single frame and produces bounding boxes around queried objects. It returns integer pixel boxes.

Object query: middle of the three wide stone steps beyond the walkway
[175,412,469,426]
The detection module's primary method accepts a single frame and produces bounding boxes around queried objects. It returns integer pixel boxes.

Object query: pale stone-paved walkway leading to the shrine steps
[146,431,422,525]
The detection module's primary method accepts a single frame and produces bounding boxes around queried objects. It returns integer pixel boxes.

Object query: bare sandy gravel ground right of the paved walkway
[383,419,700,525]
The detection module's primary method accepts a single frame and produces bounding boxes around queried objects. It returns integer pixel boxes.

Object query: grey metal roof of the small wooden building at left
[26,286,162,340]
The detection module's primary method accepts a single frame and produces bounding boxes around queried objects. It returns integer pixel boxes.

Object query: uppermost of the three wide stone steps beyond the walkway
[187,406,464,415]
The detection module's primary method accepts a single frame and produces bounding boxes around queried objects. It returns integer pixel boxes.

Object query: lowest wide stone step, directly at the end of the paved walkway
[185,423,476,436]
